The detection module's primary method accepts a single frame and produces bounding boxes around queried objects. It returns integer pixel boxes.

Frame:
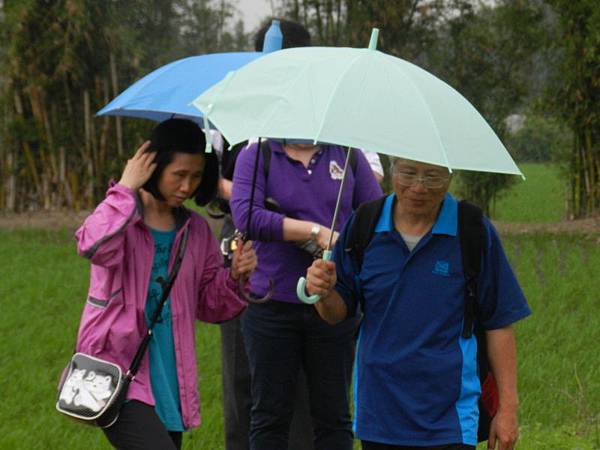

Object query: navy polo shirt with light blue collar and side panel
[334,194,530,446]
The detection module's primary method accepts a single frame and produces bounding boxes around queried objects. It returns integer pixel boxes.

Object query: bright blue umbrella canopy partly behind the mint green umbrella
[98,52,263,123]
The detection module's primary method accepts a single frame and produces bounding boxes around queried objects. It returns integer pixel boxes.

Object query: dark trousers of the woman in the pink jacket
[102,400,182,450]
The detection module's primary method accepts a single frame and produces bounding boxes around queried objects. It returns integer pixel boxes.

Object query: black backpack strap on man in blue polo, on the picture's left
[345,196,386,269]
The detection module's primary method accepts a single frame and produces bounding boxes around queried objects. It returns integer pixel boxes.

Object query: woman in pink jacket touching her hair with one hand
[76,119,256,450]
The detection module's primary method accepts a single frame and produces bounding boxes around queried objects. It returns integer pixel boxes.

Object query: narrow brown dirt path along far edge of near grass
[0,211,600,237]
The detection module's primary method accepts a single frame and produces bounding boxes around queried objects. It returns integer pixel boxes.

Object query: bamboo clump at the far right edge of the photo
[547,0,600,217]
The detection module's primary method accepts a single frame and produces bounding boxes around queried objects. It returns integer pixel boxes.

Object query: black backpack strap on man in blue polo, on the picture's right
[458,200,485,338]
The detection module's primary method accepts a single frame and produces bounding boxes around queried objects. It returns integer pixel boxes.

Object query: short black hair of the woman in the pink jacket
[142,119,219,206]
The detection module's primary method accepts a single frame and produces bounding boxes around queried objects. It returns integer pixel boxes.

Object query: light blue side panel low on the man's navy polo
[456,335,481,445]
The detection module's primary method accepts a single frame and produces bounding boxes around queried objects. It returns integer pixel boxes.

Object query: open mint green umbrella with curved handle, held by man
[193,29,522,303]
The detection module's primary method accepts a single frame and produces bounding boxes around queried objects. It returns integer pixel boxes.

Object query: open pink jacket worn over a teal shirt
[75,184,246,428]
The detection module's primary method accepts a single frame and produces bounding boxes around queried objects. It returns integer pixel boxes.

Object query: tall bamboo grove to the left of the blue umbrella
[0,0,247,211]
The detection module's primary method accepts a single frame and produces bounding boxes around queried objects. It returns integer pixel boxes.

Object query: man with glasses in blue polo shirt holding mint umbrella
[307,159,530,450]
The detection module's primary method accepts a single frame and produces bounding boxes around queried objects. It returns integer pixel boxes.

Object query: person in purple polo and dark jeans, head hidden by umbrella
[230,141,382,450]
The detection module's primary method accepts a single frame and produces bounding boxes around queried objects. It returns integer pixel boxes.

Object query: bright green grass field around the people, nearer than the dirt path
[0,165,600,450]
